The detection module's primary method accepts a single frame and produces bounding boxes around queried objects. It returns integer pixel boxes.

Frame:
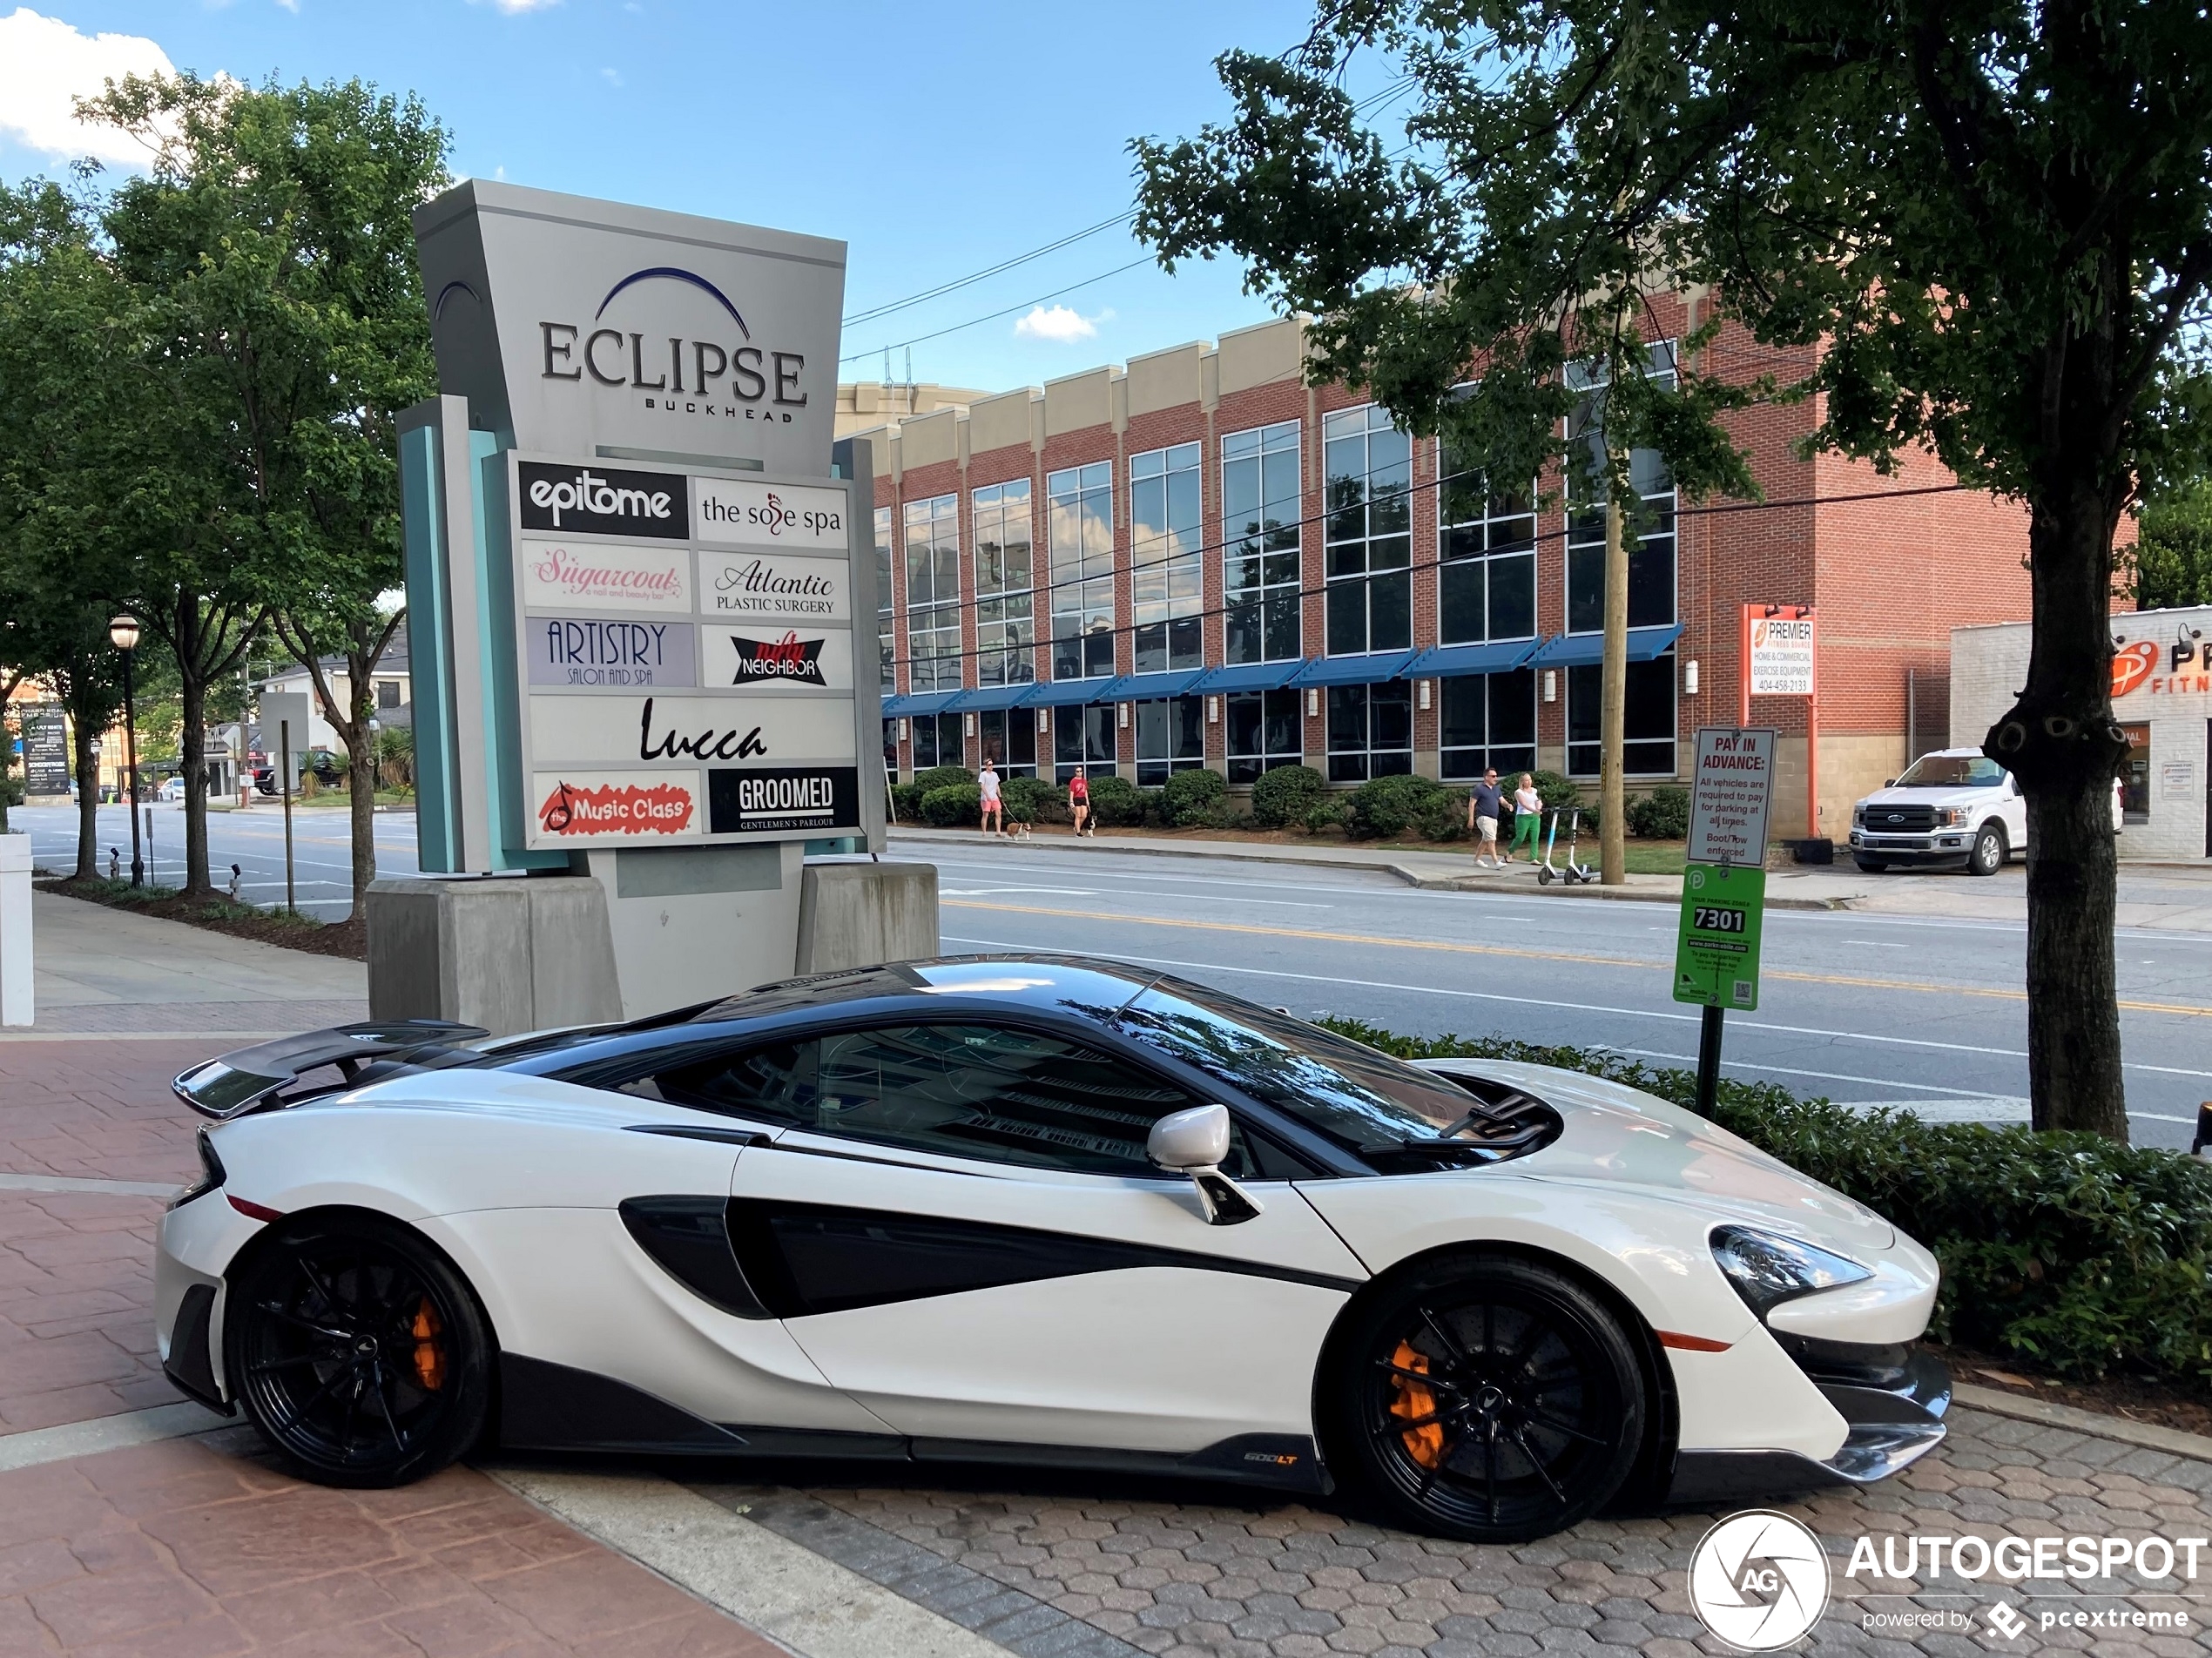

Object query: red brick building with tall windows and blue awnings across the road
[859,300,2028,840]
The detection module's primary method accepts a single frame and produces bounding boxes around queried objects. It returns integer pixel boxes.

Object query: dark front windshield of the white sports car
[1115,980,1474,1149]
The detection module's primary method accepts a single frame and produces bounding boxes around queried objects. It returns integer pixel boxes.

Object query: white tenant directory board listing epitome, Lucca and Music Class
[509,453,860,849]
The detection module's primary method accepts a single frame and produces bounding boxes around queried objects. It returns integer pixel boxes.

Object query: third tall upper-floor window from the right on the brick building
[1320,405,1413,657]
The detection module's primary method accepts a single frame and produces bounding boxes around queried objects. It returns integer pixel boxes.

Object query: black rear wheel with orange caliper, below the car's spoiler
[224,1216,491,1486]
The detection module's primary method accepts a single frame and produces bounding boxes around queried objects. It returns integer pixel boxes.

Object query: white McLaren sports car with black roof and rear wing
[157,957,1949,1540]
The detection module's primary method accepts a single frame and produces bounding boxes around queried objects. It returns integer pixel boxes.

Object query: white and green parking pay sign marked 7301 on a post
[1675,725,1774,1010]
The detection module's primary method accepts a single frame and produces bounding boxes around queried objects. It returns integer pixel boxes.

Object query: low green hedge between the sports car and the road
[1320,1019,2212,1386]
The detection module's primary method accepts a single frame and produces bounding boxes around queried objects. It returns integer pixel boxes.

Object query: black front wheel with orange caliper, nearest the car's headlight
[1330,1256,1648,1543]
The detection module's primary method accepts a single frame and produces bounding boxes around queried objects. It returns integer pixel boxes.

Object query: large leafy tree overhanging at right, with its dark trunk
[1137,0,2212,1138]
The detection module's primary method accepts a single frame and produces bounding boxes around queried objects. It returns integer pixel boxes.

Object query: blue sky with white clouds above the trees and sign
[0,0,1312,389]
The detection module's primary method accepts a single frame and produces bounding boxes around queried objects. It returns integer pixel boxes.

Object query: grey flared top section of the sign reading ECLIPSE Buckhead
[416,179,845,477]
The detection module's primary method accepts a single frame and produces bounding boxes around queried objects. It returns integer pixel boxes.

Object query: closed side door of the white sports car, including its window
[730,1019,1365,1454]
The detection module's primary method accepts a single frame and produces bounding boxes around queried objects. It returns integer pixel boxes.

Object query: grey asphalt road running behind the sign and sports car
[9,807,2212,1145]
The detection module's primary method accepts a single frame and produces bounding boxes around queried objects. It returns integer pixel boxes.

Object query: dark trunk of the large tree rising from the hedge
[1982,468,2128,1141]
